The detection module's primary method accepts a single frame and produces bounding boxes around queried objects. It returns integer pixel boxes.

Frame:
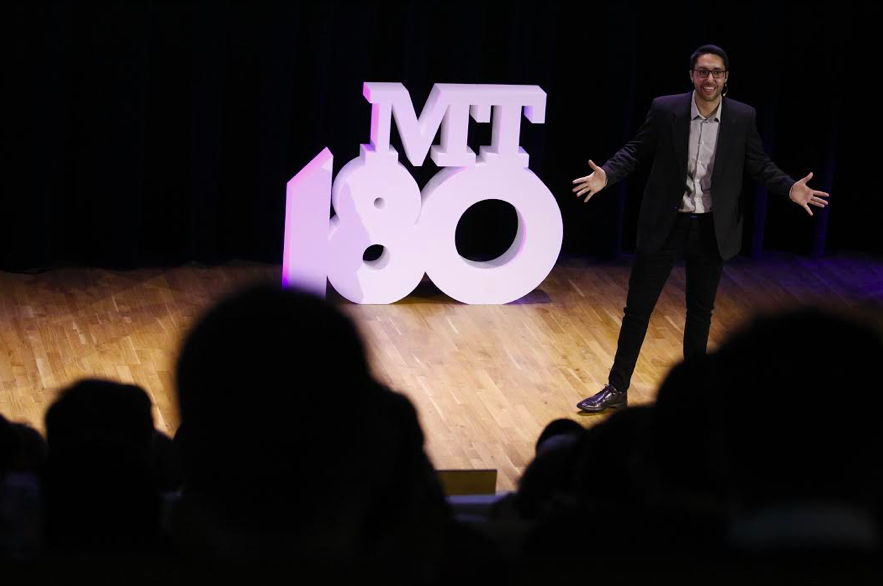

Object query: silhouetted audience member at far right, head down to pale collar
[710,308,883,551]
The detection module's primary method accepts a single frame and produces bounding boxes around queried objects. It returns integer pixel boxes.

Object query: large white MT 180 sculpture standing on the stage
[282,82,563,303]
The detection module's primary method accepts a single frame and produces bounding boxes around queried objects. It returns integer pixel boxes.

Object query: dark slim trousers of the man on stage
[608,213,723,391]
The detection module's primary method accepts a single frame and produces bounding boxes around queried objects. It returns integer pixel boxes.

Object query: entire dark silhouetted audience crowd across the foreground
[0,285,883,580]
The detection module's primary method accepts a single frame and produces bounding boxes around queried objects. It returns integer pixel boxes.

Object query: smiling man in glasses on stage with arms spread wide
[573,45,828,412]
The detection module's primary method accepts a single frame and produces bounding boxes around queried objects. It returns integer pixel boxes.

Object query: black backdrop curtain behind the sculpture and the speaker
[0,0,883,269]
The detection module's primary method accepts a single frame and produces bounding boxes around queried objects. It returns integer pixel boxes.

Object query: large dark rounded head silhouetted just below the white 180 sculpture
[177,286,371,502]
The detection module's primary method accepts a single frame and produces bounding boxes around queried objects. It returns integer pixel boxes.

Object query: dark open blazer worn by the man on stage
[602,91,794,260]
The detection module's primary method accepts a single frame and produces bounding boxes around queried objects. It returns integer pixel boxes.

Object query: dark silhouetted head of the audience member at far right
[709,308,883,505]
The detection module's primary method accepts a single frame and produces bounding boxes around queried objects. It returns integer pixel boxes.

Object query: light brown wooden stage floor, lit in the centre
[0,254,883,490]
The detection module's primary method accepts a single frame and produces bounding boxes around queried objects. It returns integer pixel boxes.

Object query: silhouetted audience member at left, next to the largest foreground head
[46,379,164,555]
